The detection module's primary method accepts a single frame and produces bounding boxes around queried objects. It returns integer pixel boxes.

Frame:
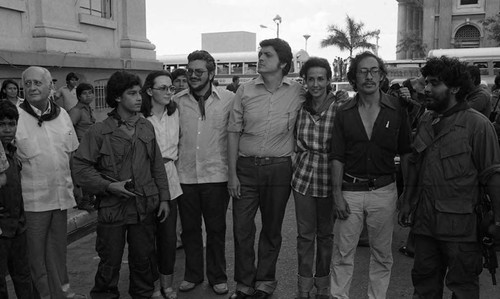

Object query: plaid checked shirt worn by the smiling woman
[292,93,338,197]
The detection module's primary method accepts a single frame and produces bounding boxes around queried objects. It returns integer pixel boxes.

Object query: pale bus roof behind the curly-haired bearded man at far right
[427,47,500,86]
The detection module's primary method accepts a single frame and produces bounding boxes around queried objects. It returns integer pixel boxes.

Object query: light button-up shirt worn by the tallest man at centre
[228,76,305,157]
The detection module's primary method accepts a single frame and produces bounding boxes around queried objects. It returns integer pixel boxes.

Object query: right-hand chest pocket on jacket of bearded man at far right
[439,138,471,180]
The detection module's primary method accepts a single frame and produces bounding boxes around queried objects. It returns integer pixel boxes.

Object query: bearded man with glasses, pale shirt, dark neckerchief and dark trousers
[174,50,234,295]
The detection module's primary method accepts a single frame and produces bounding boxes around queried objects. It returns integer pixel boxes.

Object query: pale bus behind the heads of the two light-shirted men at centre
[158,50,309,86]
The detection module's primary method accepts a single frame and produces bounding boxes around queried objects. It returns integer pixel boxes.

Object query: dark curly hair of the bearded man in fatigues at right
[420,56,472,102]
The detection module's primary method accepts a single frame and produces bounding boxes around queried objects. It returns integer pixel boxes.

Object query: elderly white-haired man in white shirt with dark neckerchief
[16,67,78,298]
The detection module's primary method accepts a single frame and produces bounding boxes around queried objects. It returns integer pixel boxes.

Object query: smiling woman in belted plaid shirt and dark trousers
[292,57,337,299]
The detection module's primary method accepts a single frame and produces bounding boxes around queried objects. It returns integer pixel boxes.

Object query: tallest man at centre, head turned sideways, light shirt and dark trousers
[228,38,305,299]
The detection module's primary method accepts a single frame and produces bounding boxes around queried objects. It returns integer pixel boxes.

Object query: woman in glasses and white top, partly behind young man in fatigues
[141,71,182,299]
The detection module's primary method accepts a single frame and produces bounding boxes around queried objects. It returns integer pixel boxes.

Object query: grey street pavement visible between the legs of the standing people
[10,198,500,299]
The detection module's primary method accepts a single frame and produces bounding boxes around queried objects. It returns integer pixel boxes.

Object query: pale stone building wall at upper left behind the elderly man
[0,0,162,119]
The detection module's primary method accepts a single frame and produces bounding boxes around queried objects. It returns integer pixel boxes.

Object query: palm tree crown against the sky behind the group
[321,16,380,58]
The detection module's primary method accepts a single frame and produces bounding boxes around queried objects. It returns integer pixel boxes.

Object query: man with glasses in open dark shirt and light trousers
[331,52,411,299]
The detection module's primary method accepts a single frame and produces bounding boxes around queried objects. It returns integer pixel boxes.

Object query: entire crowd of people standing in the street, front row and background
[0,38,500,299]
